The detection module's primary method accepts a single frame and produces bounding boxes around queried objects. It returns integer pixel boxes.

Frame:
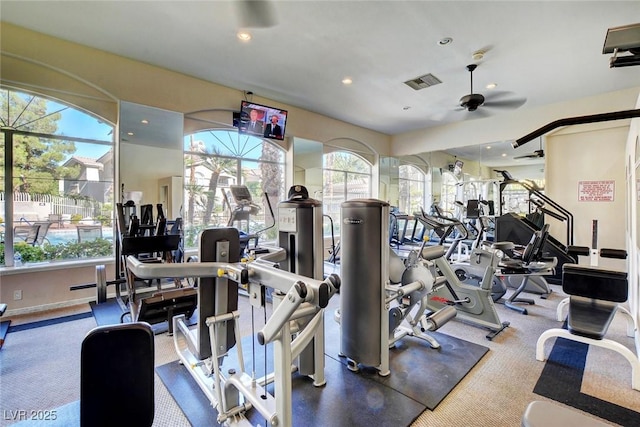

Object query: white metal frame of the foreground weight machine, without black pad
[127,252,340,427]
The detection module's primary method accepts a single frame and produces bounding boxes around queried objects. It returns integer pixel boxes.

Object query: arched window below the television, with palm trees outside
[183,129,286,247]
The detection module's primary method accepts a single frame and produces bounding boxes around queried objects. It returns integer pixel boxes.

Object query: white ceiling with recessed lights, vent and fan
[0,0,640,166]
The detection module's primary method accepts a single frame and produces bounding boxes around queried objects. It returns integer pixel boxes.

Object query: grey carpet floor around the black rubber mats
[0,286,640,427]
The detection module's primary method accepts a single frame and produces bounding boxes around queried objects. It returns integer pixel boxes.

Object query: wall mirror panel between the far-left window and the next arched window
[116,101,184,219]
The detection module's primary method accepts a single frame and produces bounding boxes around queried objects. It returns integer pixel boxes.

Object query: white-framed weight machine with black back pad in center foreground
[127,228,340,427]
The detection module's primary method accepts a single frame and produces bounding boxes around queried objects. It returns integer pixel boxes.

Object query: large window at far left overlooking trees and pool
[0,88,114,266]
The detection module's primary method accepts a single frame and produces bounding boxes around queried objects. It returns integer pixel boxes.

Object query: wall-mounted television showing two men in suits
[238,101,288,140]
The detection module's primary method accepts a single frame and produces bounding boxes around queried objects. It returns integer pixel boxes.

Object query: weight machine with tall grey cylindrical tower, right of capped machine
[335,199,456,376]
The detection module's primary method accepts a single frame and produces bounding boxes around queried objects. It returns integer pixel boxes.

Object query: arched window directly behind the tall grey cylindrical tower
[322,151,371,234]
